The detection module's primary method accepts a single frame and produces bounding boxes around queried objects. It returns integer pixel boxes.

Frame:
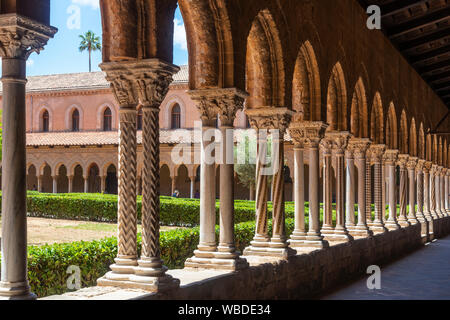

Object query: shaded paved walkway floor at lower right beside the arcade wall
[322,236,450,300]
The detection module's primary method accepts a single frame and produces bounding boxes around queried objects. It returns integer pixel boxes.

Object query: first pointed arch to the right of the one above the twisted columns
[292,41,322,121]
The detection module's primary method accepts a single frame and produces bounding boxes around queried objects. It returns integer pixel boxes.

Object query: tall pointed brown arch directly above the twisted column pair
[246,9,285,108]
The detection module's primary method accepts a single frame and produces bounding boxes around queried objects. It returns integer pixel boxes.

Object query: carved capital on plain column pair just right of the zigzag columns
[188,88,248,126]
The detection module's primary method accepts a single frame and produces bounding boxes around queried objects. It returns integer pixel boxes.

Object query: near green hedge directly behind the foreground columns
[2,219,294,297]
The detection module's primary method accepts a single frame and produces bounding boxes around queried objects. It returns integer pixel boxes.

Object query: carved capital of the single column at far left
[0,14,58,60]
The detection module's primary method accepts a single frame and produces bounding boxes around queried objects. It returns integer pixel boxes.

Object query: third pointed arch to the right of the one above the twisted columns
[350,77,369,138]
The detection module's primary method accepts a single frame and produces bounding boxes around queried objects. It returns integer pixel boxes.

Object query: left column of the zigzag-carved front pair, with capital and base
[97,62,139,287]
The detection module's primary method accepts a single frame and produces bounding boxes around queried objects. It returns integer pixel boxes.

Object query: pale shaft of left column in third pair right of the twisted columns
[345,149,356,231]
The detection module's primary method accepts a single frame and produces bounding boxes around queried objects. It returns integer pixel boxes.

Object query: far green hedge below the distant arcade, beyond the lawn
[2,192,294,227]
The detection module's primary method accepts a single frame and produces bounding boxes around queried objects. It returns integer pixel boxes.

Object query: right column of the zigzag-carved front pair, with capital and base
[126,59,180,292]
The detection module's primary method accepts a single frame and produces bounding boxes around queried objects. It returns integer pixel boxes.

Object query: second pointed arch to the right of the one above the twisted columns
[327,62,348,131]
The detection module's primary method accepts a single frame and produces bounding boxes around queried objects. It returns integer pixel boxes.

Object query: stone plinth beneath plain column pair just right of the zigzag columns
[184,252,249,271]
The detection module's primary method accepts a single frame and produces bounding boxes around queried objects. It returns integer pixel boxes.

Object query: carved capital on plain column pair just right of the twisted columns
[289,121,328,147]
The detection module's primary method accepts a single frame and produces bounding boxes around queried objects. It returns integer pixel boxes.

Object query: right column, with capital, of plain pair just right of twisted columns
[289,121,329,248]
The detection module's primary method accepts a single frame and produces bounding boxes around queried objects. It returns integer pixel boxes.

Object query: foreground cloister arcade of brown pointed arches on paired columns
[0,0,450,299]
